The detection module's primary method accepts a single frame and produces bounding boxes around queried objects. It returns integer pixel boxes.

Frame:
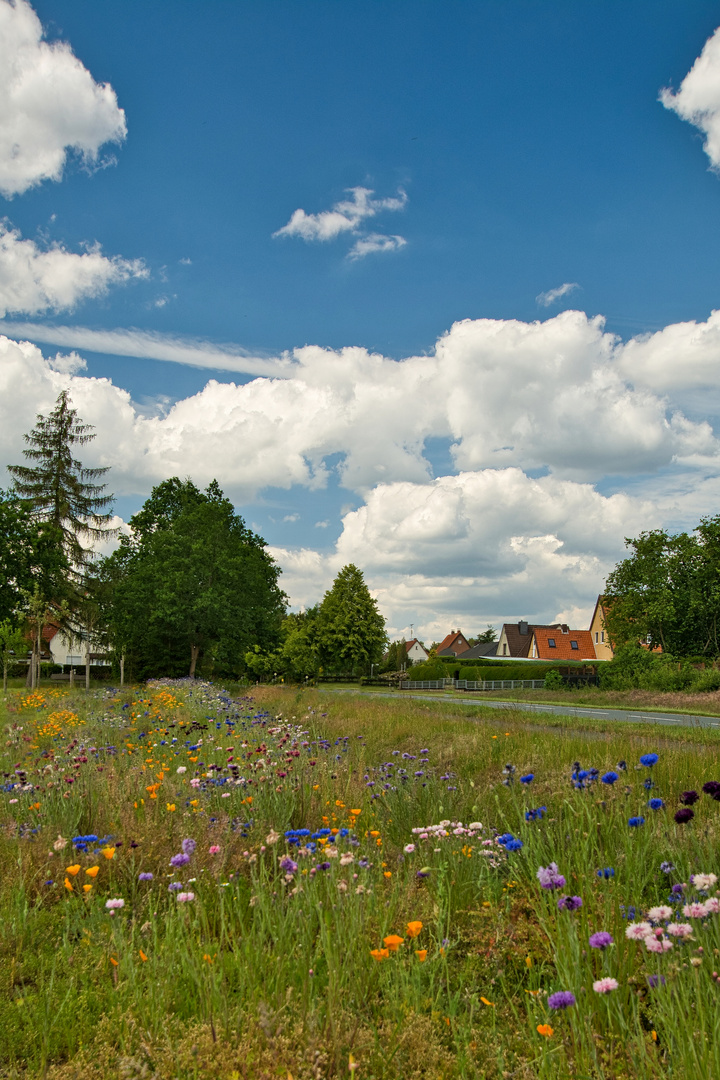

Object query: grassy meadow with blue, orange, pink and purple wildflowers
[0,680,720,1080]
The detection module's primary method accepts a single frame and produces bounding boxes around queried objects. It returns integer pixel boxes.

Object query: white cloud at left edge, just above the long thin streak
[0,220,148,315]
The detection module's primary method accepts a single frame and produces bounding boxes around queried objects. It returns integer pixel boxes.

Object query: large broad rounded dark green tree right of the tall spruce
[98,477,284,678]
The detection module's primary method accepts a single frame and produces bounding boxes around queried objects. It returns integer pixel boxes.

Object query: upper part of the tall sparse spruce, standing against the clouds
[8,390,114,578]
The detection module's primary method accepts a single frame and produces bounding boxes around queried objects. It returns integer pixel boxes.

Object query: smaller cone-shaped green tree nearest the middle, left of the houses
[317,563,388,675]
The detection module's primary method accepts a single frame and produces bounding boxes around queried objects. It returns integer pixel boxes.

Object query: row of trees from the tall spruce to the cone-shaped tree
[0,391,386,685]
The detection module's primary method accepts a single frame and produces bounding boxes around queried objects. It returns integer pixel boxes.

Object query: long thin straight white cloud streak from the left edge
[0,320,295,378]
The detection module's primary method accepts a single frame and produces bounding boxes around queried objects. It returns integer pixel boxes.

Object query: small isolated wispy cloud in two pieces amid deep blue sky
[273,188,408,259]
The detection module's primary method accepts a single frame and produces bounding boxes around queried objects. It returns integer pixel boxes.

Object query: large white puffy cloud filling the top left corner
[0,0,127,198]
